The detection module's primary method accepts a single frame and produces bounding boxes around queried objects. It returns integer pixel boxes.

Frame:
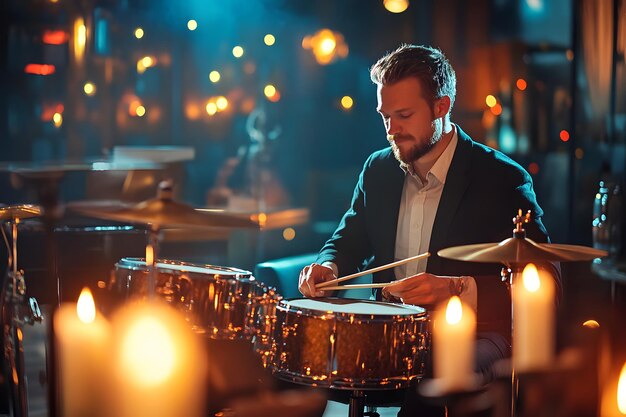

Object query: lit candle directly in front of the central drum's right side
[433,296,476,392]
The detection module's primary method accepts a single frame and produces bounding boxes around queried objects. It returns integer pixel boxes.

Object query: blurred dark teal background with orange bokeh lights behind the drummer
[0,0,626,312]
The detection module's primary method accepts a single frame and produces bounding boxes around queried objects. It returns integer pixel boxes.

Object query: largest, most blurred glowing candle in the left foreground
[108,302,207,417]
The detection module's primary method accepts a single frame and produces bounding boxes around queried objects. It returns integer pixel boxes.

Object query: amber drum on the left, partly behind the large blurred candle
[111,258,263,339]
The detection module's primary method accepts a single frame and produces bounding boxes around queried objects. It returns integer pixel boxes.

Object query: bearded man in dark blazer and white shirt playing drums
[299,45,560,414]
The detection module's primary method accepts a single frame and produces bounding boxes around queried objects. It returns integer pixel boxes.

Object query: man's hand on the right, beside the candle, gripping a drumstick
[383,272,458,306]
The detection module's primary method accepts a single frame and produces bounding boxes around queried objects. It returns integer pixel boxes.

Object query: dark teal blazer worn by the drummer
[317,126,560,336]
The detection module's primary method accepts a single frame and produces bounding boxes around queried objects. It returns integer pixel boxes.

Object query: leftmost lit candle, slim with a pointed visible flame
[54,288,110,417]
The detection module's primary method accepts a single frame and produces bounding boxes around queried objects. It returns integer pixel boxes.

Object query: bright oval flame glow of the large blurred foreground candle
[121,313,176,387]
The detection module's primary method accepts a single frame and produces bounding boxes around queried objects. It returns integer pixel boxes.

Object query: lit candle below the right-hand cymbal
[513,263,554,372]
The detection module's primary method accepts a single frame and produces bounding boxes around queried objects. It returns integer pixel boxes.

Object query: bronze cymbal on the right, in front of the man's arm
[437,237,608,265]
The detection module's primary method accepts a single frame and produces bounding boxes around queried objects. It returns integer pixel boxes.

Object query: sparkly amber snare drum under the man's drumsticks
[271,298,430,390]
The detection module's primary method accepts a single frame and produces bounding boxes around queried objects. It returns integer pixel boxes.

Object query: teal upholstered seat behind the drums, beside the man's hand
[254,253,372,300]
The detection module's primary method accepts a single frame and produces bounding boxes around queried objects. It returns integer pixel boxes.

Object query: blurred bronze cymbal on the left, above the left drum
[67,198,259,229]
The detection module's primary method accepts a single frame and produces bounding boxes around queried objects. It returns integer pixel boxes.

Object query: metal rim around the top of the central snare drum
[276,297,428,321]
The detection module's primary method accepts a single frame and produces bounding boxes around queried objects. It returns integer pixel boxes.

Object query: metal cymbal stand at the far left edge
[0,218,42,417]
